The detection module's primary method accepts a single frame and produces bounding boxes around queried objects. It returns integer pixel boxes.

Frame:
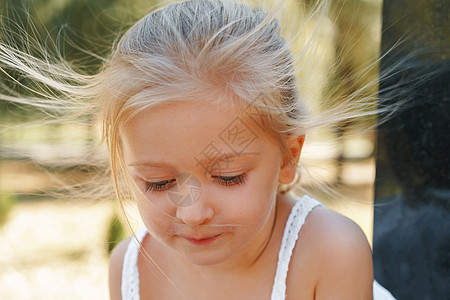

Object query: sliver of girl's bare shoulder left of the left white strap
[109,237,132,300]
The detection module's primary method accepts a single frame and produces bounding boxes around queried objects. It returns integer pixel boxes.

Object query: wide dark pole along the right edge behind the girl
[373,0,450,300]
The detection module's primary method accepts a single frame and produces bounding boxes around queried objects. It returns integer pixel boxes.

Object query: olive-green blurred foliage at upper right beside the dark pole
[324,0,381,109]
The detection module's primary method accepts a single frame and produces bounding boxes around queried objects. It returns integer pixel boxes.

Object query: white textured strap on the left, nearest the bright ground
[121,227,147,300]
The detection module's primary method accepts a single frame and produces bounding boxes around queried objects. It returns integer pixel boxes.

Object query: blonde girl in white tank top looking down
[0,0,391,299]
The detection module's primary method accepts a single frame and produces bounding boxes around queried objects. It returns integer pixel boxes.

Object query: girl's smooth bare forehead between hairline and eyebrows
[121,100,273,166]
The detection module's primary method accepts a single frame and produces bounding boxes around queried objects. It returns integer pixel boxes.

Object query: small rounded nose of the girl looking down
[176,196,214,226]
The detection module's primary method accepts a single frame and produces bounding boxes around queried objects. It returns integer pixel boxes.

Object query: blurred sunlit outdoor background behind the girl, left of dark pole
[0,0,382,299]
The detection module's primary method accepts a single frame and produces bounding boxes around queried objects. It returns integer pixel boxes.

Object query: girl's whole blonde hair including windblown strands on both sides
[0,0,384,199]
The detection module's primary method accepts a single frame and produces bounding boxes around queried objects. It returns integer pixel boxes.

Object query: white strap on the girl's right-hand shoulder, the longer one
[271,195,321,300]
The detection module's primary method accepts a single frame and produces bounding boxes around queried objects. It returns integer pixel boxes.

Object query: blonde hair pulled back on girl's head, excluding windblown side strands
[99,0,312,199]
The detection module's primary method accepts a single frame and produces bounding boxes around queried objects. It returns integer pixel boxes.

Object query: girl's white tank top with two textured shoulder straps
[121,196,395,300]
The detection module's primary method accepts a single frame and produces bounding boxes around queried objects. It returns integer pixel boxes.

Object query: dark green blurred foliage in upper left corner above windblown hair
[0,0,159,122]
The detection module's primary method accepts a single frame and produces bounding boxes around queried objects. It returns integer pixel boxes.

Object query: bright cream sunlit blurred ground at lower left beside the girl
[0,200,112,300]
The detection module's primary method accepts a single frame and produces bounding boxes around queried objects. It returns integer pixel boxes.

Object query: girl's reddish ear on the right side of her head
[278,135,305,184]
